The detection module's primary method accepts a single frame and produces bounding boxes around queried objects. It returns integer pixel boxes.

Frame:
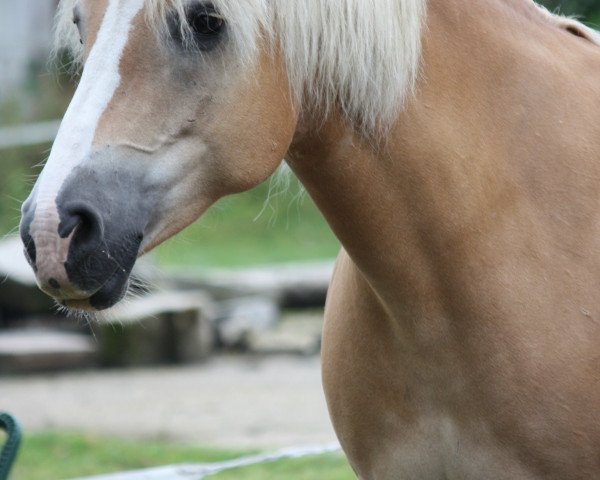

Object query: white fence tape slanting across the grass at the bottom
[71,442,342,480]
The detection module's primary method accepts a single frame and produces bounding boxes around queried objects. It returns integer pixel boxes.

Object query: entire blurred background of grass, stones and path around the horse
[0,0,600,480]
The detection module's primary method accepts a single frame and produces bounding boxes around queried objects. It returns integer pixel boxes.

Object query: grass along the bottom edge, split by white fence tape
[11,432,356,480]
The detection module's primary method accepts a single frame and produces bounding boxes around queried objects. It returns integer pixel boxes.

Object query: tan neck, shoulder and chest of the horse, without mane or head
[291,0,600,480]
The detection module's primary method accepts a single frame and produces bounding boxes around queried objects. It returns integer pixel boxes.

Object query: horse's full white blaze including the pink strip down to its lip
[30,0,144,292]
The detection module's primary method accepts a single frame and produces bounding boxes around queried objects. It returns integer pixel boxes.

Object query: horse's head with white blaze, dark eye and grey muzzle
[20,0,296,310]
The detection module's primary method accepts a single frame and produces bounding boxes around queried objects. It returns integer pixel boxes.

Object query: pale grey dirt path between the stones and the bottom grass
[0,356,335,448]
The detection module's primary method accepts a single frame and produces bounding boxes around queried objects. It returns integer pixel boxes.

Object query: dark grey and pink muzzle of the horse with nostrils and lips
[20,162,151,310]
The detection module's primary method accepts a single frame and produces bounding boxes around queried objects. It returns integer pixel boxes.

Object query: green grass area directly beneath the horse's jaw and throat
[154,176,340,269]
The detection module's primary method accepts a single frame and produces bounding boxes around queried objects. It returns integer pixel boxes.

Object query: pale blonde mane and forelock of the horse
[55,0,426,132]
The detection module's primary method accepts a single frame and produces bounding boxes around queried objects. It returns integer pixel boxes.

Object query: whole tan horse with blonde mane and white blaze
[21,0,600,480]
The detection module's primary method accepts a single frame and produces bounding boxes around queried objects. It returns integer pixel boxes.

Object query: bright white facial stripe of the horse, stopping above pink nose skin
[36,0,144,208]
